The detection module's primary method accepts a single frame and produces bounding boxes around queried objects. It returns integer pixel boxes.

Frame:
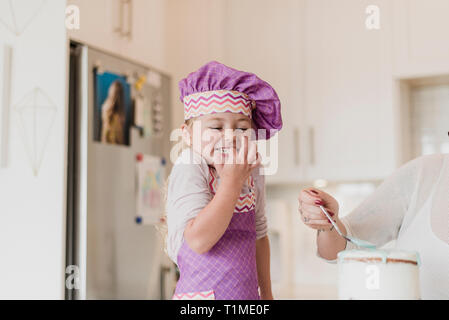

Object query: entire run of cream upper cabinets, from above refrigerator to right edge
[69,0,442,184]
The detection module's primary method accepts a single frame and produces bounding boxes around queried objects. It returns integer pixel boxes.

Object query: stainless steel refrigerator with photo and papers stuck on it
[66,42,176,299]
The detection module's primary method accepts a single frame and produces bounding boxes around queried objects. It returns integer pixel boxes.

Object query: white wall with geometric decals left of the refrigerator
[0,0,67,299]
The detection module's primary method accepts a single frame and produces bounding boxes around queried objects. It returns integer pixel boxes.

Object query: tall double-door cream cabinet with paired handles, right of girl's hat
[224,0,398,184]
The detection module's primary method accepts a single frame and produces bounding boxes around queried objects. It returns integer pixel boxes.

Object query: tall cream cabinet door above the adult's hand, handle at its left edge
[304,0,397,181]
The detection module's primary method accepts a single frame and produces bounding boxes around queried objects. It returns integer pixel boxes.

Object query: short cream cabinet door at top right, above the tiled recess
[393,0,449,77]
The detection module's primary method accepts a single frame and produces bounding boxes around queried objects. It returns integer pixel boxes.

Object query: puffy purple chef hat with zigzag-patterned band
[179,61,282,139]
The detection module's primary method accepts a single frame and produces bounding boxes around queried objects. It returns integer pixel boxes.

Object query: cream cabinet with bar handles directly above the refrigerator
[68,0,166,70]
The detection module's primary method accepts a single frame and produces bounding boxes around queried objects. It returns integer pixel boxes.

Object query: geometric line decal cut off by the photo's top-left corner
[0,0,47,36]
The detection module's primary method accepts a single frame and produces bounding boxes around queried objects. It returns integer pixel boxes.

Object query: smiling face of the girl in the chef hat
[181,112,254,164]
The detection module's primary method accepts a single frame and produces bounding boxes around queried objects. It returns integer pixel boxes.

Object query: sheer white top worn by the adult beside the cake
[328,154,449,299]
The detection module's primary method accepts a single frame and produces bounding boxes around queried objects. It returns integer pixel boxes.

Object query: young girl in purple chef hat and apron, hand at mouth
[166,62,282,300]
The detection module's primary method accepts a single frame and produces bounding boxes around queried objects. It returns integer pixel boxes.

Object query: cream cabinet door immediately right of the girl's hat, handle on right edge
[224,0,304,183]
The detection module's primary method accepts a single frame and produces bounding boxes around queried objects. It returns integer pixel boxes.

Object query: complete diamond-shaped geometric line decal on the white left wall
[14,87,57,176]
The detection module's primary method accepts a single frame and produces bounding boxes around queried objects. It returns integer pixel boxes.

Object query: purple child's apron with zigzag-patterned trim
[173,167,260,300]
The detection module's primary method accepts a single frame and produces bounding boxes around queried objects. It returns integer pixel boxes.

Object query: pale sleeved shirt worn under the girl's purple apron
[166,149,267,263]
